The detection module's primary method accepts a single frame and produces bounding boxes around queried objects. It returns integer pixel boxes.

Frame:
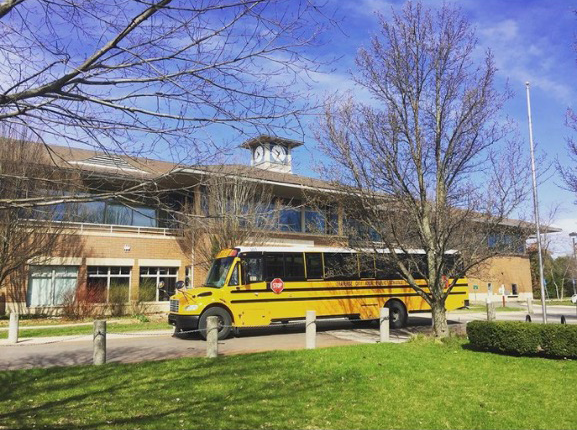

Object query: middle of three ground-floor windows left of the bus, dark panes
[86,266,131,303]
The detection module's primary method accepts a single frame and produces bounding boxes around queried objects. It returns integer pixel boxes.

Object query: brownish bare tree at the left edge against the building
[0,129,82,310]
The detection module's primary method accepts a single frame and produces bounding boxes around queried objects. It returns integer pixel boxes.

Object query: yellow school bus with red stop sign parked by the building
[168,246,469,339]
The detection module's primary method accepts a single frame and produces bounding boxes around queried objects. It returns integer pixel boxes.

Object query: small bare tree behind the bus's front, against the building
[181,172,278,278]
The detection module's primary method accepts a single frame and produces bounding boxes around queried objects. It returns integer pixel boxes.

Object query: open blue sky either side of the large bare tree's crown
[256,0,577,254]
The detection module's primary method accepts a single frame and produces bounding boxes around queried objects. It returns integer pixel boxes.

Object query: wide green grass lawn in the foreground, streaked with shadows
[0,341,577,429]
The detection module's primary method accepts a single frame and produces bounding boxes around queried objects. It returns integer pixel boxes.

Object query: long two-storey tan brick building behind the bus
[1,136,548,313]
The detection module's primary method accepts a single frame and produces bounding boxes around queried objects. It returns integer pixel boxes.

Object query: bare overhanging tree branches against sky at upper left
[0,0,330,206]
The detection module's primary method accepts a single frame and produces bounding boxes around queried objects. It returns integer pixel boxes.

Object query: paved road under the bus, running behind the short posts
[0,306,577,370]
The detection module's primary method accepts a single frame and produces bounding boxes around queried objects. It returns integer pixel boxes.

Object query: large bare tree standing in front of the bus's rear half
[317,2,528,336]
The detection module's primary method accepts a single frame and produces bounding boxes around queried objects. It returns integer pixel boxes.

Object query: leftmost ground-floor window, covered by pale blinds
[26,266,78,307]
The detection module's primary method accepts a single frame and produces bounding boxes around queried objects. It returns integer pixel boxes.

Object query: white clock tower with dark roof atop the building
[241,135,303,173]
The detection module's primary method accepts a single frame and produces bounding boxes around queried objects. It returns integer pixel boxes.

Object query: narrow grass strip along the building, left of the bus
[0,321,171,340]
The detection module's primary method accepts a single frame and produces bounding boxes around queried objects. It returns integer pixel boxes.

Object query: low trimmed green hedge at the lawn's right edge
[467,321,577,358]
